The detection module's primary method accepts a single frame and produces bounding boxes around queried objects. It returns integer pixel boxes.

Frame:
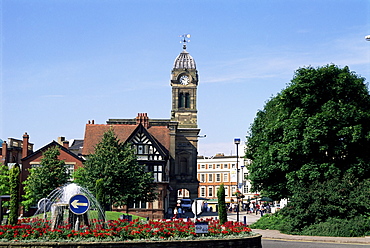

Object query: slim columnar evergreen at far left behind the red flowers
[9,164,21,225]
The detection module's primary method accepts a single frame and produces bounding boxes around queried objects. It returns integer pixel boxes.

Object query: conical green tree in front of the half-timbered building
[76,128,156,209]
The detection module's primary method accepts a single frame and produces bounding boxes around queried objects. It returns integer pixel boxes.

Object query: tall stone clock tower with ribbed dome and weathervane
[170,35,200,207]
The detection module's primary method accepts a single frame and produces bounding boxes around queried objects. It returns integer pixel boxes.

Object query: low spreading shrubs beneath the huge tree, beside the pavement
[281,175,370,231]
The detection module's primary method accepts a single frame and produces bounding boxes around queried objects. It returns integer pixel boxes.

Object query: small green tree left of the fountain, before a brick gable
[22,147,69,209]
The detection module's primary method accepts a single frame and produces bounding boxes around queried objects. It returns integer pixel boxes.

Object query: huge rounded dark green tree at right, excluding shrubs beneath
[246,65,370,201]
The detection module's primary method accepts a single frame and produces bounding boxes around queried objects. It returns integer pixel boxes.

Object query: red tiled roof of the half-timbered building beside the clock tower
[82,124,170,155]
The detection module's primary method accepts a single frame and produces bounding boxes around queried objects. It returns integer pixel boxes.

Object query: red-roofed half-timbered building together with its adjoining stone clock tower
[82,40,200,218]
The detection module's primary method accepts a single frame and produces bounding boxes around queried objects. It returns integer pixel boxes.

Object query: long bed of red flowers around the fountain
[0,218,251,241]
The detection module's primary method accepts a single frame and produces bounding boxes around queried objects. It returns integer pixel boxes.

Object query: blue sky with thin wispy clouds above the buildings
[0,0,370,156]
